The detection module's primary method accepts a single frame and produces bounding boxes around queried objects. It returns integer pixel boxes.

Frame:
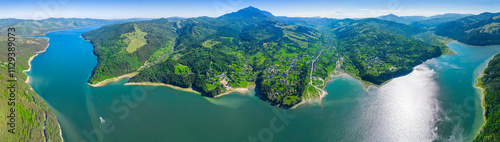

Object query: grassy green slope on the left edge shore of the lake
[0,36,62,142]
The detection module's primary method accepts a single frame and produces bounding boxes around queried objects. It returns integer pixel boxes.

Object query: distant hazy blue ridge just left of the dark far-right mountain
[411,13,471,29]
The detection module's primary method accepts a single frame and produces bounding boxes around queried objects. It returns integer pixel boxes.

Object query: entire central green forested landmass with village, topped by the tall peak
[83,7,454,108]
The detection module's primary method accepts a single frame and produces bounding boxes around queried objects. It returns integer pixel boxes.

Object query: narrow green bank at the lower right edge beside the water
[474,55,500,142]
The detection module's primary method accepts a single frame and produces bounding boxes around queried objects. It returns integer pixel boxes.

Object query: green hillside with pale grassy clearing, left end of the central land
[82,20,178,83]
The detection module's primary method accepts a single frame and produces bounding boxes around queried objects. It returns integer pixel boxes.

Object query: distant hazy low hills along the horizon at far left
[0,18,147,35]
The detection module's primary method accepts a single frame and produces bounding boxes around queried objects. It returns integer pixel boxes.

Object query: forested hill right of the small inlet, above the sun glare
[330,19,446,84]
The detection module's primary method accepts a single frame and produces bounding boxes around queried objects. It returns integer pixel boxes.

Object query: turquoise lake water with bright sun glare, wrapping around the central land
[28,27,500,142]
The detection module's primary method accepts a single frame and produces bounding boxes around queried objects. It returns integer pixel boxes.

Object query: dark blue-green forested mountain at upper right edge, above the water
[434,13,500,46]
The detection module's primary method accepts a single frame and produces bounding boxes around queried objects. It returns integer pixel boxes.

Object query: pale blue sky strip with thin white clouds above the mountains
[0,0,500,20]
